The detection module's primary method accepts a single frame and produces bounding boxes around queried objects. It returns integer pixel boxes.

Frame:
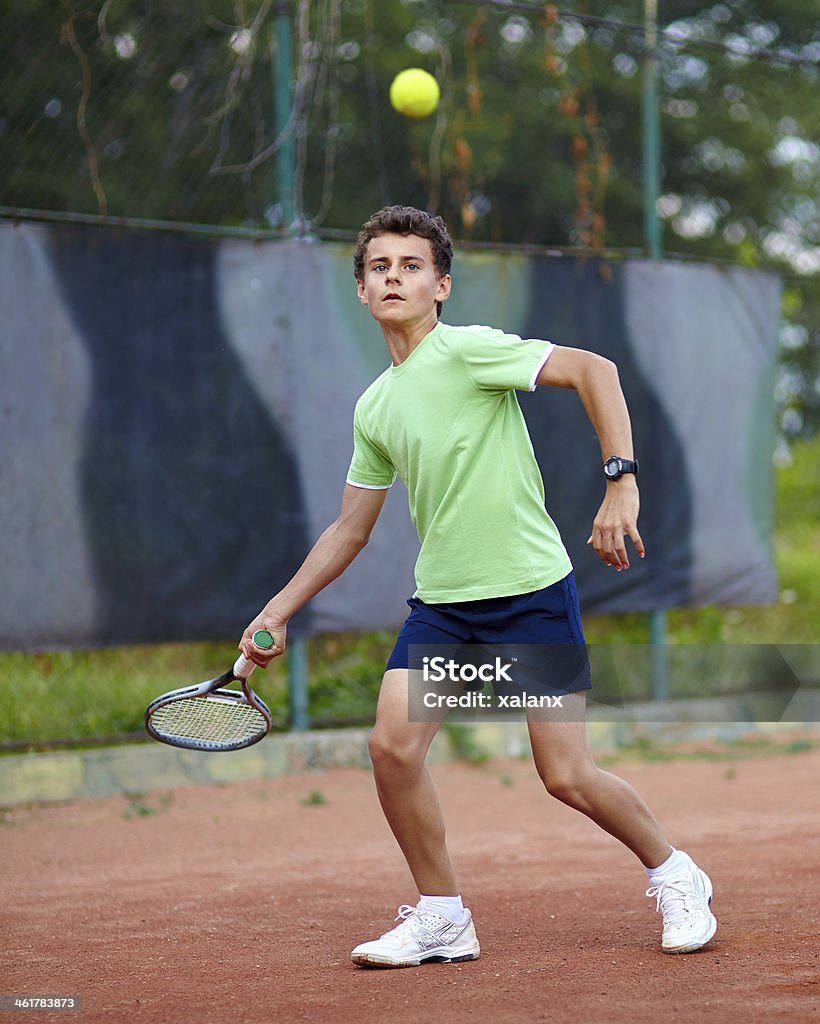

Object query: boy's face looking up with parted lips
[358,234,450,327]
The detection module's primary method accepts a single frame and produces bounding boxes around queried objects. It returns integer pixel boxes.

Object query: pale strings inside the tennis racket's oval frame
[145,694,267,744]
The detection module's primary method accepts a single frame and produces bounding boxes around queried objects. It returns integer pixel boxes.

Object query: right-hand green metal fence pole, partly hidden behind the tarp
[641,0,670,700]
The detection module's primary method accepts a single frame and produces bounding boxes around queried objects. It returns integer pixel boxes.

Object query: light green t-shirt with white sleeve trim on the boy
[347,323,572,603]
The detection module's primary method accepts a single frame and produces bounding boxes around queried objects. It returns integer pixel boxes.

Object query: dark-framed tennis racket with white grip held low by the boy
[145,630,273,751]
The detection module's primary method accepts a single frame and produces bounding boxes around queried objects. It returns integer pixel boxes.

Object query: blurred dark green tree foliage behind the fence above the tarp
[0,0,820,436]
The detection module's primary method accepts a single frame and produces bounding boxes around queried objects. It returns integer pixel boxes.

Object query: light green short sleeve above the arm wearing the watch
[461,328,555,391]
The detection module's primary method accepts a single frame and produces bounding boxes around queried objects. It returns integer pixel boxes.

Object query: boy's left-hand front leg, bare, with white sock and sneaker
[350,669,481,968]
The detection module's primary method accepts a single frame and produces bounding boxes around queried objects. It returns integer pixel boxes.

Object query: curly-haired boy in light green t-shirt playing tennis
[240,206,717,967]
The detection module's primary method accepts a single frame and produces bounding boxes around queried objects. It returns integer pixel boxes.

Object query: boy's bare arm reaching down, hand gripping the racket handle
[240,483,387,667]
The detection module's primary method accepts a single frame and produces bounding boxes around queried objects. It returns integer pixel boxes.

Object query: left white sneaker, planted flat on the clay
[350,904,481,967]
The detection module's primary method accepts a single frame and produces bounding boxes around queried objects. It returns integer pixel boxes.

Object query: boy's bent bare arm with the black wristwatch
[537,347,645,571]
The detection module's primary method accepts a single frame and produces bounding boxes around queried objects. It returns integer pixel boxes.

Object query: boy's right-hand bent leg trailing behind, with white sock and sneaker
[527,693,718,953]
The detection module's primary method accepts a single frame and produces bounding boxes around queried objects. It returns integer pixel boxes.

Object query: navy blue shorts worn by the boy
[387,572,592,692]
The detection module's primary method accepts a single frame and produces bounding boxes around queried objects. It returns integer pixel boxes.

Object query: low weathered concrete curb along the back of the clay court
[0,690,820,807]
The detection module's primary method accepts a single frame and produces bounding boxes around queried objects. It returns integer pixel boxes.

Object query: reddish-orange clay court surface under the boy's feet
[0,750,820,1024]
